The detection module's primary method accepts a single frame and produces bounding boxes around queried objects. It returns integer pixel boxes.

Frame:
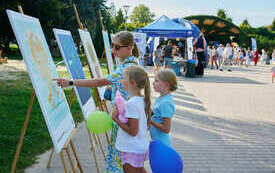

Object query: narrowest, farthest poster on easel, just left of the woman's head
[102,31,114,73]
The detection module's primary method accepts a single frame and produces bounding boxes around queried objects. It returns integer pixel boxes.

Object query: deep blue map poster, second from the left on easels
[53,29,96,119]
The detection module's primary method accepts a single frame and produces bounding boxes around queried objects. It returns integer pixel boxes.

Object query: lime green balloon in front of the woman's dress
[87,111,113,134]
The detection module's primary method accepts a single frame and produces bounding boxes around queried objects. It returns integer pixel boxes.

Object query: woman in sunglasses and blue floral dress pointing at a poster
[54,31,140,173]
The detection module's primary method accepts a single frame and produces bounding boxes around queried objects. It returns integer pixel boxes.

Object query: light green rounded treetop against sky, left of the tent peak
[130,4,155,24]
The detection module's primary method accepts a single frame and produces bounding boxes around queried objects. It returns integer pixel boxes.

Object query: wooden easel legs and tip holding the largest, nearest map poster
[10,5,84,173]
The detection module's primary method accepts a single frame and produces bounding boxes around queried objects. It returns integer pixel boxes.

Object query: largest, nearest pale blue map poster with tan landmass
[7,10,75,153]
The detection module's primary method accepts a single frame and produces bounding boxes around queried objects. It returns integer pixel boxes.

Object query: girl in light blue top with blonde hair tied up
[150,69,177,146]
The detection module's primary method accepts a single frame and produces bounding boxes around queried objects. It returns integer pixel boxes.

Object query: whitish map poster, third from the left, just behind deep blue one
[78,29,105,100]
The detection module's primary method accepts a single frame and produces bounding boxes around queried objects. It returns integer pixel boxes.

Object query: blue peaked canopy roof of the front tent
[136,15,193,38]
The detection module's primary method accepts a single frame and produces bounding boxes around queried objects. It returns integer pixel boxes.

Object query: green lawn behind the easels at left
[0,64,107,173]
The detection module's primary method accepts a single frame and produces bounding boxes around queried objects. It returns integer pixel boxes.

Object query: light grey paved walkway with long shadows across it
[26,65,275,173]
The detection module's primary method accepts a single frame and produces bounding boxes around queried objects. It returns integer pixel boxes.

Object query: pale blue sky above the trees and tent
[107,0,275,27]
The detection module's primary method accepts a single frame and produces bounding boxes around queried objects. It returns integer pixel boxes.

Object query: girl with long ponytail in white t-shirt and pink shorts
[112,66,151,173]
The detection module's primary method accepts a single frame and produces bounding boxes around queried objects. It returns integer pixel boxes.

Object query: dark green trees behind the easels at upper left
[0,0,112,60]
